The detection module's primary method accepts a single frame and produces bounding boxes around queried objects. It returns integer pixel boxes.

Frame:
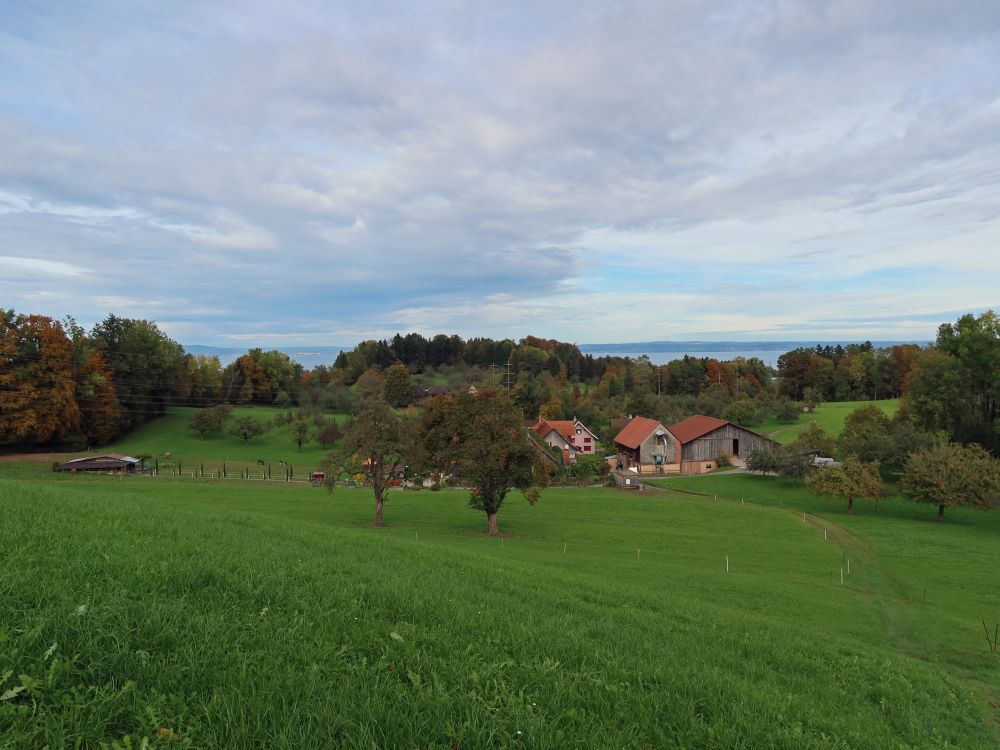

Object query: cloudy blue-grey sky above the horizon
[0,0,1000,346]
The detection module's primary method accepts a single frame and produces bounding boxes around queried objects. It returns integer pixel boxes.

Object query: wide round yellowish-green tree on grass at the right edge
[903,443,1000,521]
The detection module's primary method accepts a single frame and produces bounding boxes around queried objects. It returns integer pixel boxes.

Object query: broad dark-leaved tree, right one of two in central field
[421,391,546,536]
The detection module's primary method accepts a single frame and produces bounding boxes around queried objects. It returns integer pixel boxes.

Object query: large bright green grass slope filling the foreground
[0,466,1000,748]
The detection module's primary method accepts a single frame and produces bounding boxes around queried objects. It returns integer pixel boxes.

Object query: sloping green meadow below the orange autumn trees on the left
[102,406,347,470]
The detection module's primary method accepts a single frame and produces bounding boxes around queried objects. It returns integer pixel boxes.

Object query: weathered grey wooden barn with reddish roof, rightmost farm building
[669,414,777,474]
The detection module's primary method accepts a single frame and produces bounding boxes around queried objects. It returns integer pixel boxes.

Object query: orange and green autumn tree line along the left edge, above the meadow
[0,309,302,449]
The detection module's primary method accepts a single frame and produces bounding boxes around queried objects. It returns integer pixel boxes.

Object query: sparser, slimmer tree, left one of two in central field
[328,390,406,526]
